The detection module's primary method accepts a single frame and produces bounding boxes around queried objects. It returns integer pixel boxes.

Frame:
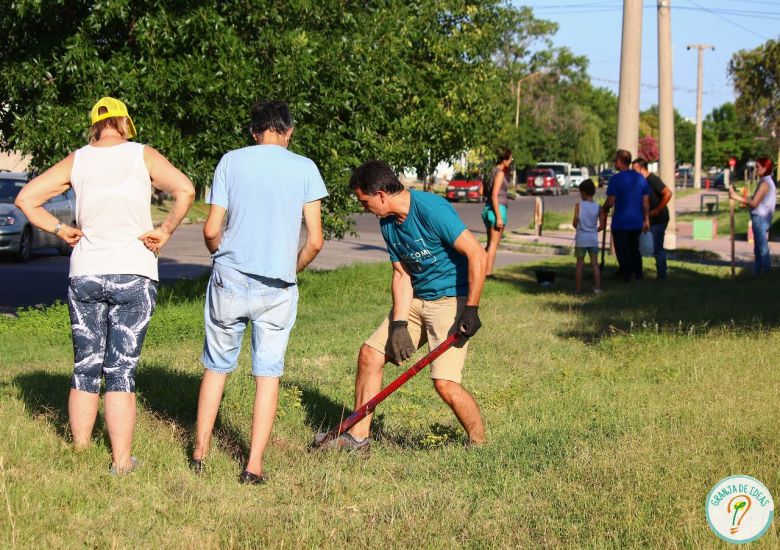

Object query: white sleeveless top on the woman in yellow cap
[70,142,159,281]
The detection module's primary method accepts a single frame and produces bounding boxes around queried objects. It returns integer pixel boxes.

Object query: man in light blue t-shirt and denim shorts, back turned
[197,101,328,485]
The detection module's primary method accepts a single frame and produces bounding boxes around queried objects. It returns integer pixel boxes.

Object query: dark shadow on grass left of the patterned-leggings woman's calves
[14,371,76,441]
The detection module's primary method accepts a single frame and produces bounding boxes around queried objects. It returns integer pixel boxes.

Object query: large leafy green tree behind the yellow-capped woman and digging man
[0,0,516,236]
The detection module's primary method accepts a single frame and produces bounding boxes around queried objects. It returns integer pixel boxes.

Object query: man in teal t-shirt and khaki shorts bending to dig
[322,160,487,449]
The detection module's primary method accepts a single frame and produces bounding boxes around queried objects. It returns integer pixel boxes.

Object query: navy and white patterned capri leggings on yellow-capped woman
[68,275,157,393]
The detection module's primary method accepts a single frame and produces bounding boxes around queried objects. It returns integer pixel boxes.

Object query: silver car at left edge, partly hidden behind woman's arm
[0,172,76,262]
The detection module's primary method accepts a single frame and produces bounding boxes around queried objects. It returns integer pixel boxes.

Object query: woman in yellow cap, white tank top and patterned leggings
[16,97,195,473]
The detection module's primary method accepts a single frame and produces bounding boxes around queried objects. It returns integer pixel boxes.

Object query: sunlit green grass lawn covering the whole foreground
[0,258,780,548]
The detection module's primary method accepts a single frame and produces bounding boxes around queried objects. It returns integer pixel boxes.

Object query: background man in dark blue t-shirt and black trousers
[604,149,650,282]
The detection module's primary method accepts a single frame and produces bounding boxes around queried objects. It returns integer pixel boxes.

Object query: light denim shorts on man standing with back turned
[202,263,298,377]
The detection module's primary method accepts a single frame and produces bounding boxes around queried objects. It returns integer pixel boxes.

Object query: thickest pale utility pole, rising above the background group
[617,0,642,157]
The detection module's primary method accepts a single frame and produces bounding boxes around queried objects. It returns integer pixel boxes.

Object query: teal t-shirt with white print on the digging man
[379,191,469,300]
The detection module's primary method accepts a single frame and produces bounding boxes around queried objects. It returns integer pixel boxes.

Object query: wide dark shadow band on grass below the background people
[496,259,780,342]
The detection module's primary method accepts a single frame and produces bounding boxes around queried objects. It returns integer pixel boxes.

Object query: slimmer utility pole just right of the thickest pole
[658,0,677,250]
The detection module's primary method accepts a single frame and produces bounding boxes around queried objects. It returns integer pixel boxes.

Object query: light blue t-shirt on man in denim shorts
[207,145,328,283]
